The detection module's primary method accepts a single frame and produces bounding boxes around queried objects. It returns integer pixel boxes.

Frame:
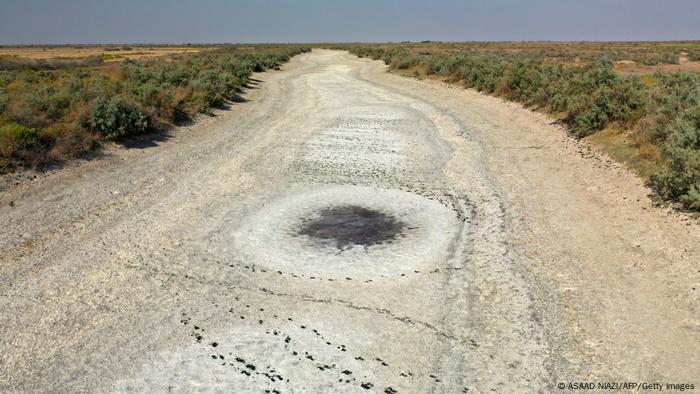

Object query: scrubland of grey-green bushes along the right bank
[335,43,700,210]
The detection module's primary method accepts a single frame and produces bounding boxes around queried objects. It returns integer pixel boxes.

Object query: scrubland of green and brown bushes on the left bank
[0,46,308,173]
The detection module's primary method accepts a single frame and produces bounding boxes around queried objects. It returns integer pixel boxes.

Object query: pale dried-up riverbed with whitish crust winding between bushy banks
[0,50,700,393]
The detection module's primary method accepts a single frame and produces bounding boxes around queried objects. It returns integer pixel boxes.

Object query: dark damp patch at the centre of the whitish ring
[299,205,404,250]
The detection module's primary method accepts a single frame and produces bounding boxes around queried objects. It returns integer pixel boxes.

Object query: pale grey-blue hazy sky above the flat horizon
[0,0,700,44]
